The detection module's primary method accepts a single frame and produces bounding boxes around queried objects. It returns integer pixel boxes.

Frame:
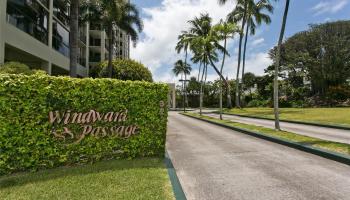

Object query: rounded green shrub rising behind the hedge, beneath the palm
[90,59,153,82]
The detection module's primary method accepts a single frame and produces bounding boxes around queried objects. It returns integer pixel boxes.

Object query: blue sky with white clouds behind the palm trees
[131,0,350,83]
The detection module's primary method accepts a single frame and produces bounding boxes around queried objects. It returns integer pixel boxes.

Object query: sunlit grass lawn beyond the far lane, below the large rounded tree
[224,108,350,127]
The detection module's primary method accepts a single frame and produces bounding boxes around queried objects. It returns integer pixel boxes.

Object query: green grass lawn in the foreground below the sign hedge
[0,158,174,200]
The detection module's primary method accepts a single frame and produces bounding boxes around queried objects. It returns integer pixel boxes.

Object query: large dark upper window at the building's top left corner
[7,0,49,44]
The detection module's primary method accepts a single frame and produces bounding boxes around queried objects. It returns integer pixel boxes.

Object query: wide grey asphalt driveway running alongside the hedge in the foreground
[167,112,350,200]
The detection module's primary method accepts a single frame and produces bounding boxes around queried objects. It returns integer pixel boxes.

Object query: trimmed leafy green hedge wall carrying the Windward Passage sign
[0,75,168,174]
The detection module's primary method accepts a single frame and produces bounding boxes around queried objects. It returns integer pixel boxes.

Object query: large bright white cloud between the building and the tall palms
[131,0,234,82]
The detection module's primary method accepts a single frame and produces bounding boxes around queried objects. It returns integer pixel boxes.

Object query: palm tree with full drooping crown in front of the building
[82,0,143,77]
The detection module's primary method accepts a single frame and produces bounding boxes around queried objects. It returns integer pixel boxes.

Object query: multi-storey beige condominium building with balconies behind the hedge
[0,0,130,77]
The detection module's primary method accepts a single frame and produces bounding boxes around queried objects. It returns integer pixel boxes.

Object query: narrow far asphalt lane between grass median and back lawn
[203,113,350,145]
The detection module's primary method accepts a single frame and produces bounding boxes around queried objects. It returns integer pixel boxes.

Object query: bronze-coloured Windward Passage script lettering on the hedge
[49,110,138,143]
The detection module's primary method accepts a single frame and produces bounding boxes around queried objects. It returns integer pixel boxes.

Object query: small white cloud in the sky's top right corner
[311,0,349,15]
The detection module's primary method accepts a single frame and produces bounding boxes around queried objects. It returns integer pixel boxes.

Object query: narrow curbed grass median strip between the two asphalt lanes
[185,113,350,155]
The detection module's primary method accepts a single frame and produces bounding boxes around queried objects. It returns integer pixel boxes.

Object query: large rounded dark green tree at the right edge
[270,21,350,99]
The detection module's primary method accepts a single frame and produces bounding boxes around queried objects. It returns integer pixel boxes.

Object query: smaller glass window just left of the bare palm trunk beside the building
[52,19,69,57]
